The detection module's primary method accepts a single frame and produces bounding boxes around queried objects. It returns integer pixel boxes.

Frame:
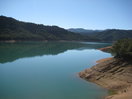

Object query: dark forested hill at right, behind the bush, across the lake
[91,29,132,42]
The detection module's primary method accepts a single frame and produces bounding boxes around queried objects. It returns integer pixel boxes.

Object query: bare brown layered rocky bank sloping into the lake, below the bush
[79,58,132,99]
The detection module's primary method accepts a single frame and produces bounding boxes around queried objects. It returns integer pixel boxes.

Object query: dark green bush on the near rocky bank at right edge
[111,39,132,60]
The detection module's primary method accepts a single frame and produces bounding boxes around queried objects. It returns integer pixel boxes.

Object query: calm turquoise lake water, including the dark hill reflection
[0,42,111,99]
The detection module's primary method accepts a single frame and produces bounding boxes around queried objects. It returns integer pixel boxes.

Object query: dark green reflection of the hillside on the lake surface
[0,42,109,63]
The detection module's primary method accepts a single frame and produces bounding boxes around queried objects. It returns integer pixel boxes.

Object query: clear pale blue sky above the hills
[0,0,132,29]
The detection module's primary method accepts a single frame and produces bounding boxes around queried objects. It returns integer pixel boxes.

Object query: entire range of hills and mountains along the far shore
[0,16,132,42]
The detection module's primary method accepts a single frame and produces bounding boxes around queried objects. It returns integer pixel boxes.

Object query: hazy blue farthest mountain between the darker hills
[68,28,103,35]
